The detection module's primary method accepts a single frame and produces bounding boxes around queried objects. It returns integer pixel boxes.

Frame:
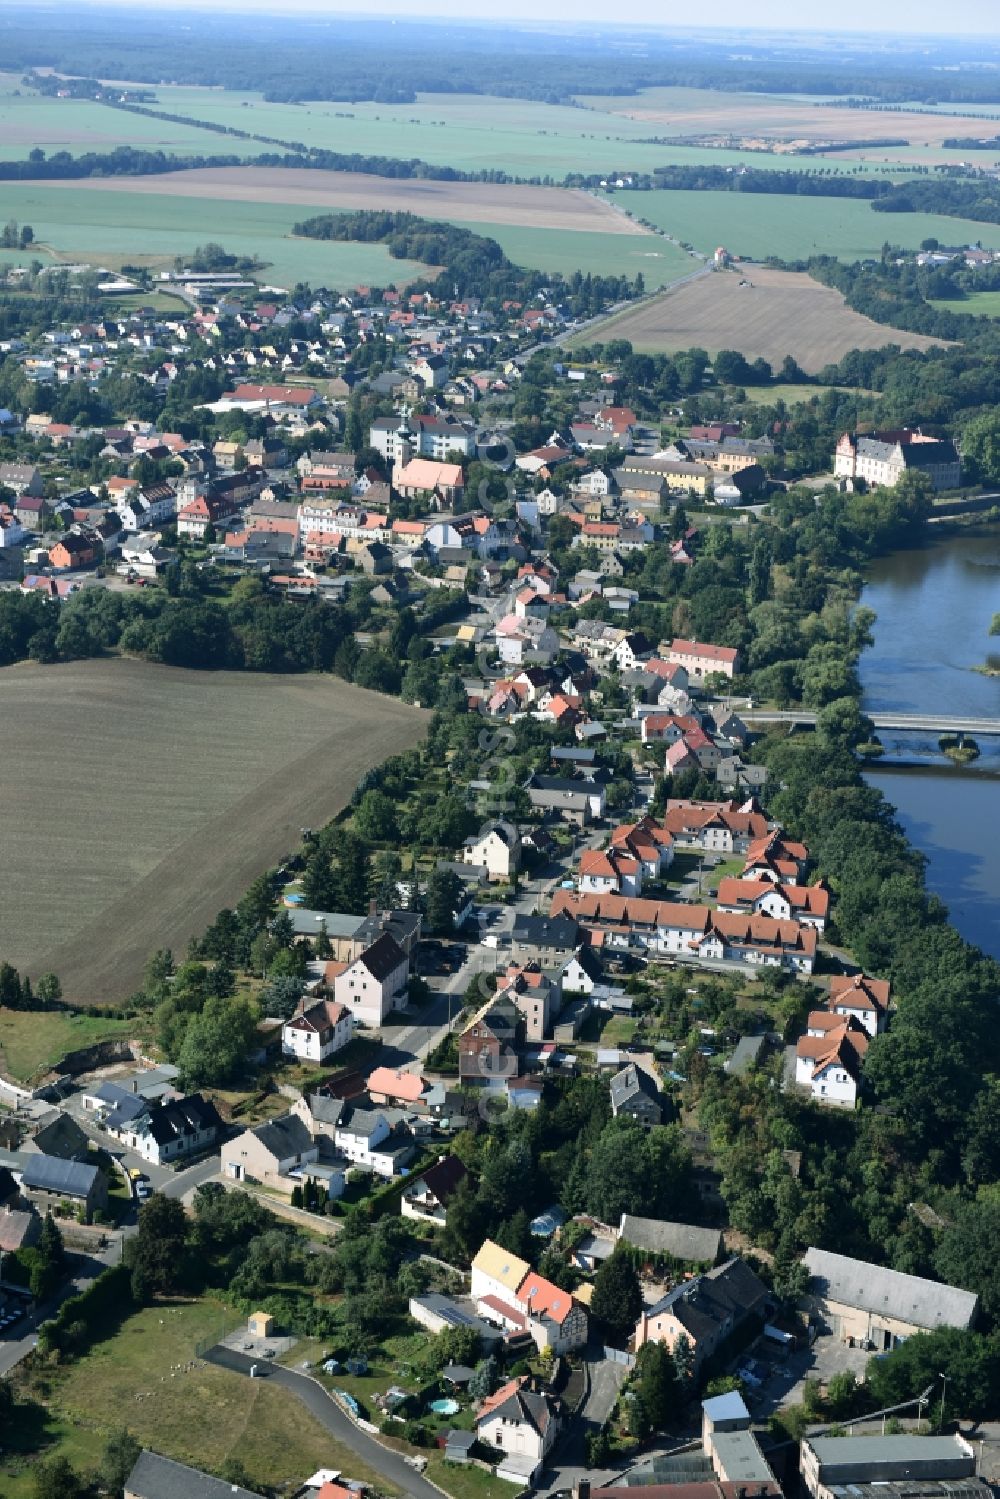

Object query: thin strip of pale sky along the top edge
[74,0,1000,40]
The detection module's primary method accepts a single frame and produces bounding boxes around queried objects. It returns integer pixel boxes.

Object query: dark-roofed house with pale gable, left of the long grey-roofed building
[636,1258,771,1373]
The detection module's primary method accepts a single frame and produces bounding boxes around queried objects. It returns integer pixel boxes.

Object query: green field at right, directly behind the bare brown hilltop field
[628,192,1000,261]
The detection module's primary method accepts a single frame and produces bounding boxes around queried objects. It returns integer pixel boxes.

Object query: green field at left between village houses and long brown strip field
[1,178,423,289]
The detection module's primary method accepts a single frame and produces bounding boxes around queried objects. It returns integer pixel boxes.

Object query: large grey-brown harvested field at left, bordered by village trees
[0,660,429,1004]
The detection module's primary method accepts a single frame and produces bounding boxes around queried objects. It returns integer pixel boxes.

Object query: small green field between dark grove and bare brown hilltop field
[454,220,699,291]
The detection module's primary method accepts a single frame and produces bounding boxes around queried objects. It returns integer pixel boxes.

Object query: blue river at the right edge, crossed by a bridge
[861,531,1000,958]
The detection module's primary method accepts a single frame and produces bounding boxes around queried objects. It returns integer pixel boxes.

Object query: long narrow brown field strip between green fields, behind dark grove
[27,166,648,235]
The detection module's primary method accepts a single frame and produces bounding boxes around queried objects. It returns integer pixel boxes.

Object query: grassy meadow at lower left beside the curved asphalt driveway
[22,1300,401,1495]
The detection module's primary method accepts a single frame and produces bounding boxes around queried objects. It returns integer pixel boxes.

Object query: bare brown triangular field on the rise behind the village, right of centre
[580,265,942,375]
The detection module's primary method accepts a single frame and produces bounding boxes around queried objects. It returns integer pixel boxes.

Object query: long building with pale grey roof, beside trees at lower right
[804,1249,979,1352]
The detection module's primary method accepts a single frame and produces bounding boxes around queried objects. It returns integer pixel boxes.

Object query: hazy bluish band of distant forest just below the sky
[0,6,1000,103]
